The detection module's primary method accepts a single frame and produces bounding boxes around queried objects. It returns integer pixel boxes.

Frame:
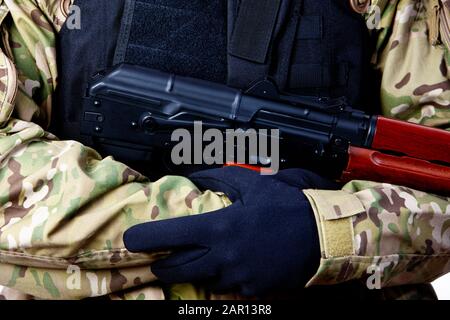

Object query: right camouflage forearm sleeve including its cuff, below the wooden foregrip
[305,181,450,288]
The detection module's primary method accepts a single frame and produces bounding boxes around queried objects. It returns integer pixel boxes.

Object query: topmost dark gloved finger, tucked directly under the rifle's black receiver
[189,167,259,202]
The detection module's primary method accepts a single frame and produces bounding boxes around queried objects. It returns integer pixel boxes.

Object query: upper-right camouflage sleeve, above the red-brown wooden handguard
[367,0,450,130]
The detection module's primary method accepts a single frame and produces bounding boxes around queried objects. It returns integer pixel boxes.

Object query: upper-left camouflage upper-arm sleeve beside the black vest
[0,0,73,128]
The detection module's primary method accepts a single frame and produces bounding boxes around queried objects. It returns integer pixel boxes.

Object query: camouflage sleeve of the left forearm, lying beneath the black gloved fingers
[0,119,229,299]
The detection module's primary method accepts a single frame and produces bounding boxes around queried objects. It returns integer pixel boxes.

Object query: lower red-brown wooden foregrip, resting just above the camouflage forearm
[341,147,450,195]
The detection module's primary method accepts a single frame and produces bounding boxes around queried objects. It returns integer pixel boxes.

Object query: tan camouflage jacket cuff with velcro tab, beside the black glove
[303,189,365,286]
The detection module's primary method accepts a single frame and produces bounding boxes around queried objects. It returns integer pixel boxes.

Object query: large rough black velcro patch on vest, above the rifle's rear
[116,0,227,82]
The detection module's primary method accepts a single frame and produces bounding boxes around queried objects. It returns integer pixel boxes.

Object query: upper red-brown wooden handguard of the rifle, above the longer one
[371,117,450,164]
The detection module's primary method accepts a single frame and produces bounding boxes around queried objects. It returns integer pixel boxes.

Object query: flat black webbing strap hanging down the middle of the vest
[229,0,281,63]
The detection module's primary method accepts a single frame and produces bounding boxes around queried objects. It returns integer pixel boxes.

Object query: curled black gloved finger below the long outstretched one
[151,253,218,284]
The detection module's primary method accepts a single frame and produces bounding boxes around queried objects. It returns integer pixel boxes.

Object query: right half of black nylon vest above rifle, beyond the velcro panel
[228,0,376,107]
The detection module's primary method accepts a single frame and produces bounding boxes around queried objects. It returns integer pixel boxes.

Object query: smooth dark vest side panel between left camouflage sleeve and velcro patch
[50,0,124,145]
